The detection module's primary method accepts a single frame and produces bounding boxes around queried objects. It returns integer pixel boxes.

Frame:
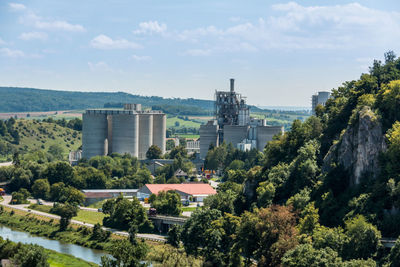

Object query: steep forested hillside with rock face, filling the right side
[181,52,400,266]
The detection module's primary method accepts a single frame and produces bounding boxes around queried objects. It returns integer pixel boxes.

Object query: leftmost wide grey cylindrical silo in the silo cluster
[82,110,108,159]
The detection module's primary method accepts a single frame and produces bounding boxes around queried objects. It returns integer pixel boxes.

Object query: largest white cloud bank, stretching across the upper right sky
[174,2,400,55]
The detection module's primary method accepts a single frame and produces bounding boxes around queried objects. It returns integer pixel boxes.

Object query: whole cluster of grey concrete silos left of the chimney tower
[82,104,166,159]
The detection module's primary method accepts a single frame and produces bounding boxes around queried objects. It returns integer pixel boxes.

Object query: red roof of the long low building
[144,183,217,195]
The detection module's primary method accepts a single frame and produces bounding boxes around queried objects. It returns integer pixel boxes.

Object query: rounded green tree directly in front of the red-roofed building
[149,190,182,216]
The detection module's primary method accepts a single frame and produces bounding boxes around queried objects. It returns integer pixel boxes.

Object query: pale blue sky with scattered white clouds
[0,0,400,106]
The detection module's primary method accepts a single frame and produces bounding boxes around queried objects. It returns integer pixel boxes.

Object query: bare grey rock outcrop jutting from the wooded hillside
[322,107,386,185]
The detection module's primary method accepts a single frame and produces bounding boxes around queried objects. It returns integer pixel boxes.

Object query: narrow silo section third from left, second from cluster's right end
[139,113,153,159]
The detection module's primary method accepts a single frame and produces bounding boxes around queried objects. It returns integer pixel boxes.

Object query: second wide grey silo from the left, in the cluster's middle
[111,113,139,157]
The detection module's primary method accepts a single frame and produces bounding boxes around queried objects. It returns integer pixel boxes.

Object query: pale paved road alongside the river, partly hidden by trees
[0,195,165,242]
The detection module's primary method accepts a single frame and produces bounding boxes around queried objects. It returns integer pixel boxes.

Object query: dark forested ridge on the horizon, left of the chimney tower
[0,87,214,115]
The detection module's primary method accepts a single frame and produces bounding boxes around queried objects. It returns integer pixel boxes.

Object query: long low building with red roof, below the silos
[138,183,217,202]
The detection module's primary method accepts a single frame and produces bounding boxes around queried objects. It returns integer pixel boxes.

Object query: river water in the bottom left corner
[0,225,107,264]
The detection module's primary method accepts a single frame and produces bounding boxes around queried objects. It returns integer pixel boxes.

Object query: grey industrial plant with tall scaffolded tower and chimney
[200,79,284,159]
